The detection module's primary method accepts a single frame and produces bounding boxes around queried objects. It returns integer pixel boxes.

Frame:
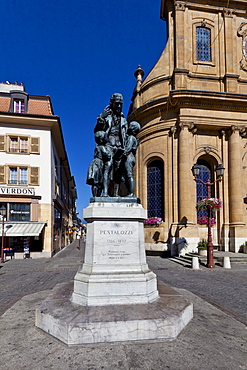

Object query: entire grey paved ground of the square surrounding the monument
[0,243,247,370]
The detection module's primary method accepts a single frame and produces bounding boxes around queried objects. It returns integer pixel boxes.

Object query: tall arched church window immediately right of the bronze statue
[147,160,164,220]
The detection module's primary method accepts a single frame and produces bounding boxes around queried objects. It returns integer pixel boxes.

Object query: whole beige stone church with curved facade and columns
[128,0,247,255]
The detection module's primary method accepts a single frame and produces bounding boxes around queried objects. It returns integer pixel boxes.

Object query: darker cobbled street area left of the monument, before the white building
[0,241,84,315]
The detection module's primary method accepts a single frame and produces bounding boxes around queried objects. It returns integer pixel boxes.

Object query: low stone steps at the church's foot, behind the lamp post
[169,251,247,267]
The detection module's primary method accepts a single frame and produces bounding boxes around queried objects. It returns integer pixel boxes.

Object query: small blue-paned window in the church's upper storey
[196,27,212,62]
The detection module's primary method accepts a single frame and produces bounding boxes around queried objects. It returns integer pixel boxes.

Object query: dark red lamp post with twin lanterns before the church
[191,163,225,268]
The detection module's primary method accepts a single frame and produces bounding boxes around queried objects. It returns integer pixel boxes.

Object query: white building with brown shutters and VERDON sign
[0,82,77,258]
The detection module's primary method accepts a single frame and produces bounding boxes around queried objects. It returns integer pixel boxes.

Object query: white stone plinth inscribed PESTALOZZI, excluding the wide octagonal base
[72,198,158,306]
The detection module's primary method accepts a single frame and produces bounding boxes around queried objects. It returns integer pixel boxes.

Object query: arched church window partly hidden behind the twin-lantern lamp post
[196,160,214,217]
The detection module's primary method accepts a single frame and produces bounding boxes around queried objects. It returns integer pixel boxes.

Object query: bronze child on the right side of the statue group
[124,121,141,197]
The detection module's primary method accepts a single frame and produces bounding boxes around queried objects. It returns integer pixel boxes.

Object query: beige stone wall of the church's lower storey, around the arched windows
[133,101,247,249]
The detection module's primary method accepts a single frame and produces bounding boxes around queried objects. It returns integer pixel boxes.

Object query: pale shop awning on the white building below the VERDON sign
[0,222,46,236]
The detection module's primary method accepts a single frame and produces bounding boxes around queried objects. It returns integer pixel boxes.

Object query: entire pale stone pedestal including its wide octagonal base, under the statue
[36,198,193,345]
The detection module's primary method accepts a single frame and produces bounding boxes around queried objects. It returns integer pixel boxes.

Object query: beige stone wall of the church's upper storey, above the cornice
[137,2,247,105]
